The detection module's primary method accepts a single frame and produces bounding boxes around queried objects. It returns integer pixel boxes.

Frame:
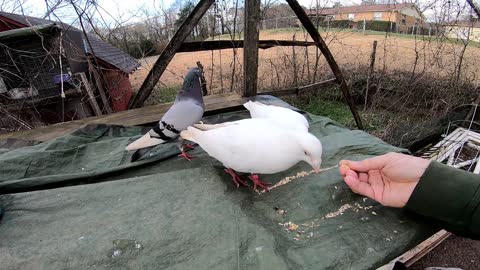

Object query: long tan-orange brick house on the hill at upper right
[308,4,426,33]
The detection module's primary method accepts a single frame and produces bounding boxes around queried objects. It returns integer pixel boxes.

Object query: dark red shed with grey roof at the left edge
[0,12,139,127]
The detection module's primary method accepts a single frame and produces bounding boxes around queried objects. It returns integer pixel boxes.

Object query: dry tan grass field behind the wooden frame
[131,29,480,92]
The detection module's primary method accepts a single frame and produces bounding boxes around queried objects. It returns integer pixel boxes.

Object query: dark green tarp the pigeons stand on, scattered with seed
[0,99,435,269]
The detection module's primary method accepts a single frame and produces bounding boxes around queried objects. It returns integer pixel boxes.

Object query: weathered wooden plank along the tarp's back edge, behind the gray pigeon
[0,93,247,141]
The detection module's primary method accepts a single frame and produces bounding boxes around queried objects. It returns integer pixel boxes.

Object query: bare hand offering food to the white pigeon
[340,153,430,207]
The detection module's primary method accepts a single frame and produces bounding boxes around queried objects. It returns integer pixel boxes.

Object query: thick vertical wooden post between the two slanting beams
[243,0,260,97]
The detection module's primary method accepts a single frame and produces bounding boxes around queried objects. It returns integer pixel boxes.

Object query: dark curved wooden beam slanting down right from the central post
[287,0,363,129]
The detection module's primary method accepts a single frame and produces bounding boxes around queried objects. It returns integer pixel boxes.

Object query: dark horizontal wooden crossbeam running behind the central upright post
[177,40,317,53]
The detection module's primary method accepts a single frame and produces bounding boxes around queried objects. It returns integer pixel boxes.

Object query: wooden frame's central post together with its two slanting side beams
[129,0,363,129]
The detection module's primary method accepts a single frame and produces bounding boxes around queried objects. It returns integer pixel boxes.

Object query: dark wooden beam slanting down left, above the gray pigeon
[129,0,215,109]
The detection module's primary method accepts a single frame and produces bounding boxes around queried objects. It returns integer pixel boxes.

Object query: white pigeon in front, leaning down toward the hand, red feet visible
[180,118,322,189]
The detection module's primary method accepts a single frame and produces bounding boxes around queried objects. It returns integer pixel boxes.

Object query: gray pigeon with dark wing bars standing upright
[126,68,205,162]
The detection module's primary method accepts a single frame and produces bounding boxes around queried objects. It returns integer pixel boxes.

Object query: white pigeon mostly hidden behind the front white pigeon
[243,101,309,131]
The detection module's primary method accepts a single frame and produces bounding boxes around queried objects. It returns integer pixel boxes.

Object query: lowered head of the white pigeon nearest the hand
[297,132,322,172]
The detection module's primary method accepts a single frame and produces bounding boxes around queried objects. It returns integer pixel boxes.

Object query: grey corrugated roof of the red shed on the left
[0,12,140,73]
